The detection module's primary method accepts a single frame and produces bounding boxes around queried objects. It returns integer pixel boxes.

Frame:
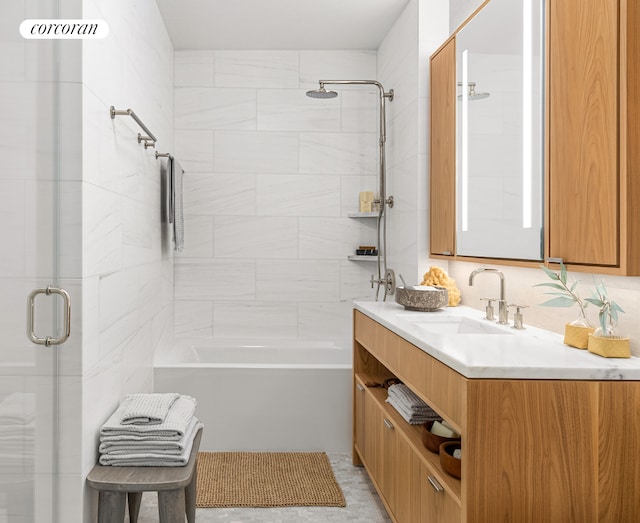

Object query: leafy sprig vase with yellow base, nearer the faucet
[535,263,595,349]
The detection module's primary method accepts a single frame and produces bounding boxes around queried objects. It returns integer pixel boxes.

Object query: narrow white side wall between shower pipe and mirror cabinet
[378,0,448,284]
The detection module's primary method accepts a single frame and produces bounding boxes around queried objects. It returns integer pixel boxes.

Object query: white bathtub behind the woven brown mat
[154,339,352,452]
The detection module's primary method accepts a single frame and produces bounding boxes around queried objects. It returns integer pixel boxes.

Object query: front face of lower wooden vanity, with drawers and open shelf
[353,312,464,523]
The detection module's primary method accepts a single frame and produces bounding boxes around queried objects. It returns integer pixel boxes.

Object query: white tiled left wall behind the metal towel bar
[77,0,174,521]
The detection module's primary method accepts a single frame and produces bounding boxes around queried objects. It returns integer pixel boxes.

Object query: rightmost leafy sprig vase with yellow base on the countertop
[585,282,631,358]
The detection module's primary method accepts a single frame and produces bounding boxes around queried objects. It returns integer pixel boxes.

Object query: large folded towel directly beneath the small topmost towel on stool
[100,396,196,441]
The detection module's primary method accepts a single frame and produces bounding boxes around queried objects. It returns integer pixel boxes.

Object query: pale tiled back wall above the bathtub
[174,50,378,346]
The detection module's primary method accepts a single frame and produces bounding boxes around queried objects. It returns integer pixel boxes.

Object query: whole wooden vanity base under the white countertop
[353,311,640,523]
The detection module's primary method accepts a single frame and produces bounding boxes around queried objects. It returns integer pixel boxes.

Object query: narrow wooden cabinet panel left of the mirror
[429,37,456,256]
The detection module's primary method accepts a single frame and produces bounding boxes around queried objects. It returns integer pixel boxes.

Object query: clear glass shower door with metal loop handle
[0,0,68,523]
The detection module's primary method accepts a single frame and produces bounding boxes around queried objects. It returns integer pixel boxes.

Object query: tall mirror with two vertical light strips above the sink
[456,0,544,260]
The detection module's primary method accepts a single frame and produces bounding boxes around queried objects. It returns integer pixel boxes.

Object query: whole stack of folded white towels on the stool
[99,394,203,467]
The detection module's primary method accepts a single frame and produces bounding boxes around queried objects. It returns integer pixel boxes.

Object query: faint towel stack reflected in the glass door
[0,392,36,473]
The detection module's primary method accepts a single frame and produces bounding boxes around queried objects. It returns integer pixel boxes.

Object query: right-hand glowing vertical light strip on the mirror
[522,0,533,229]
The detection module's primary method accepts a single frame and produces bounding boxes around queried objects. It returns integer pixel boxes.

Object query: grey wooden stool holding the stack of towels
[87,429,202,523]
